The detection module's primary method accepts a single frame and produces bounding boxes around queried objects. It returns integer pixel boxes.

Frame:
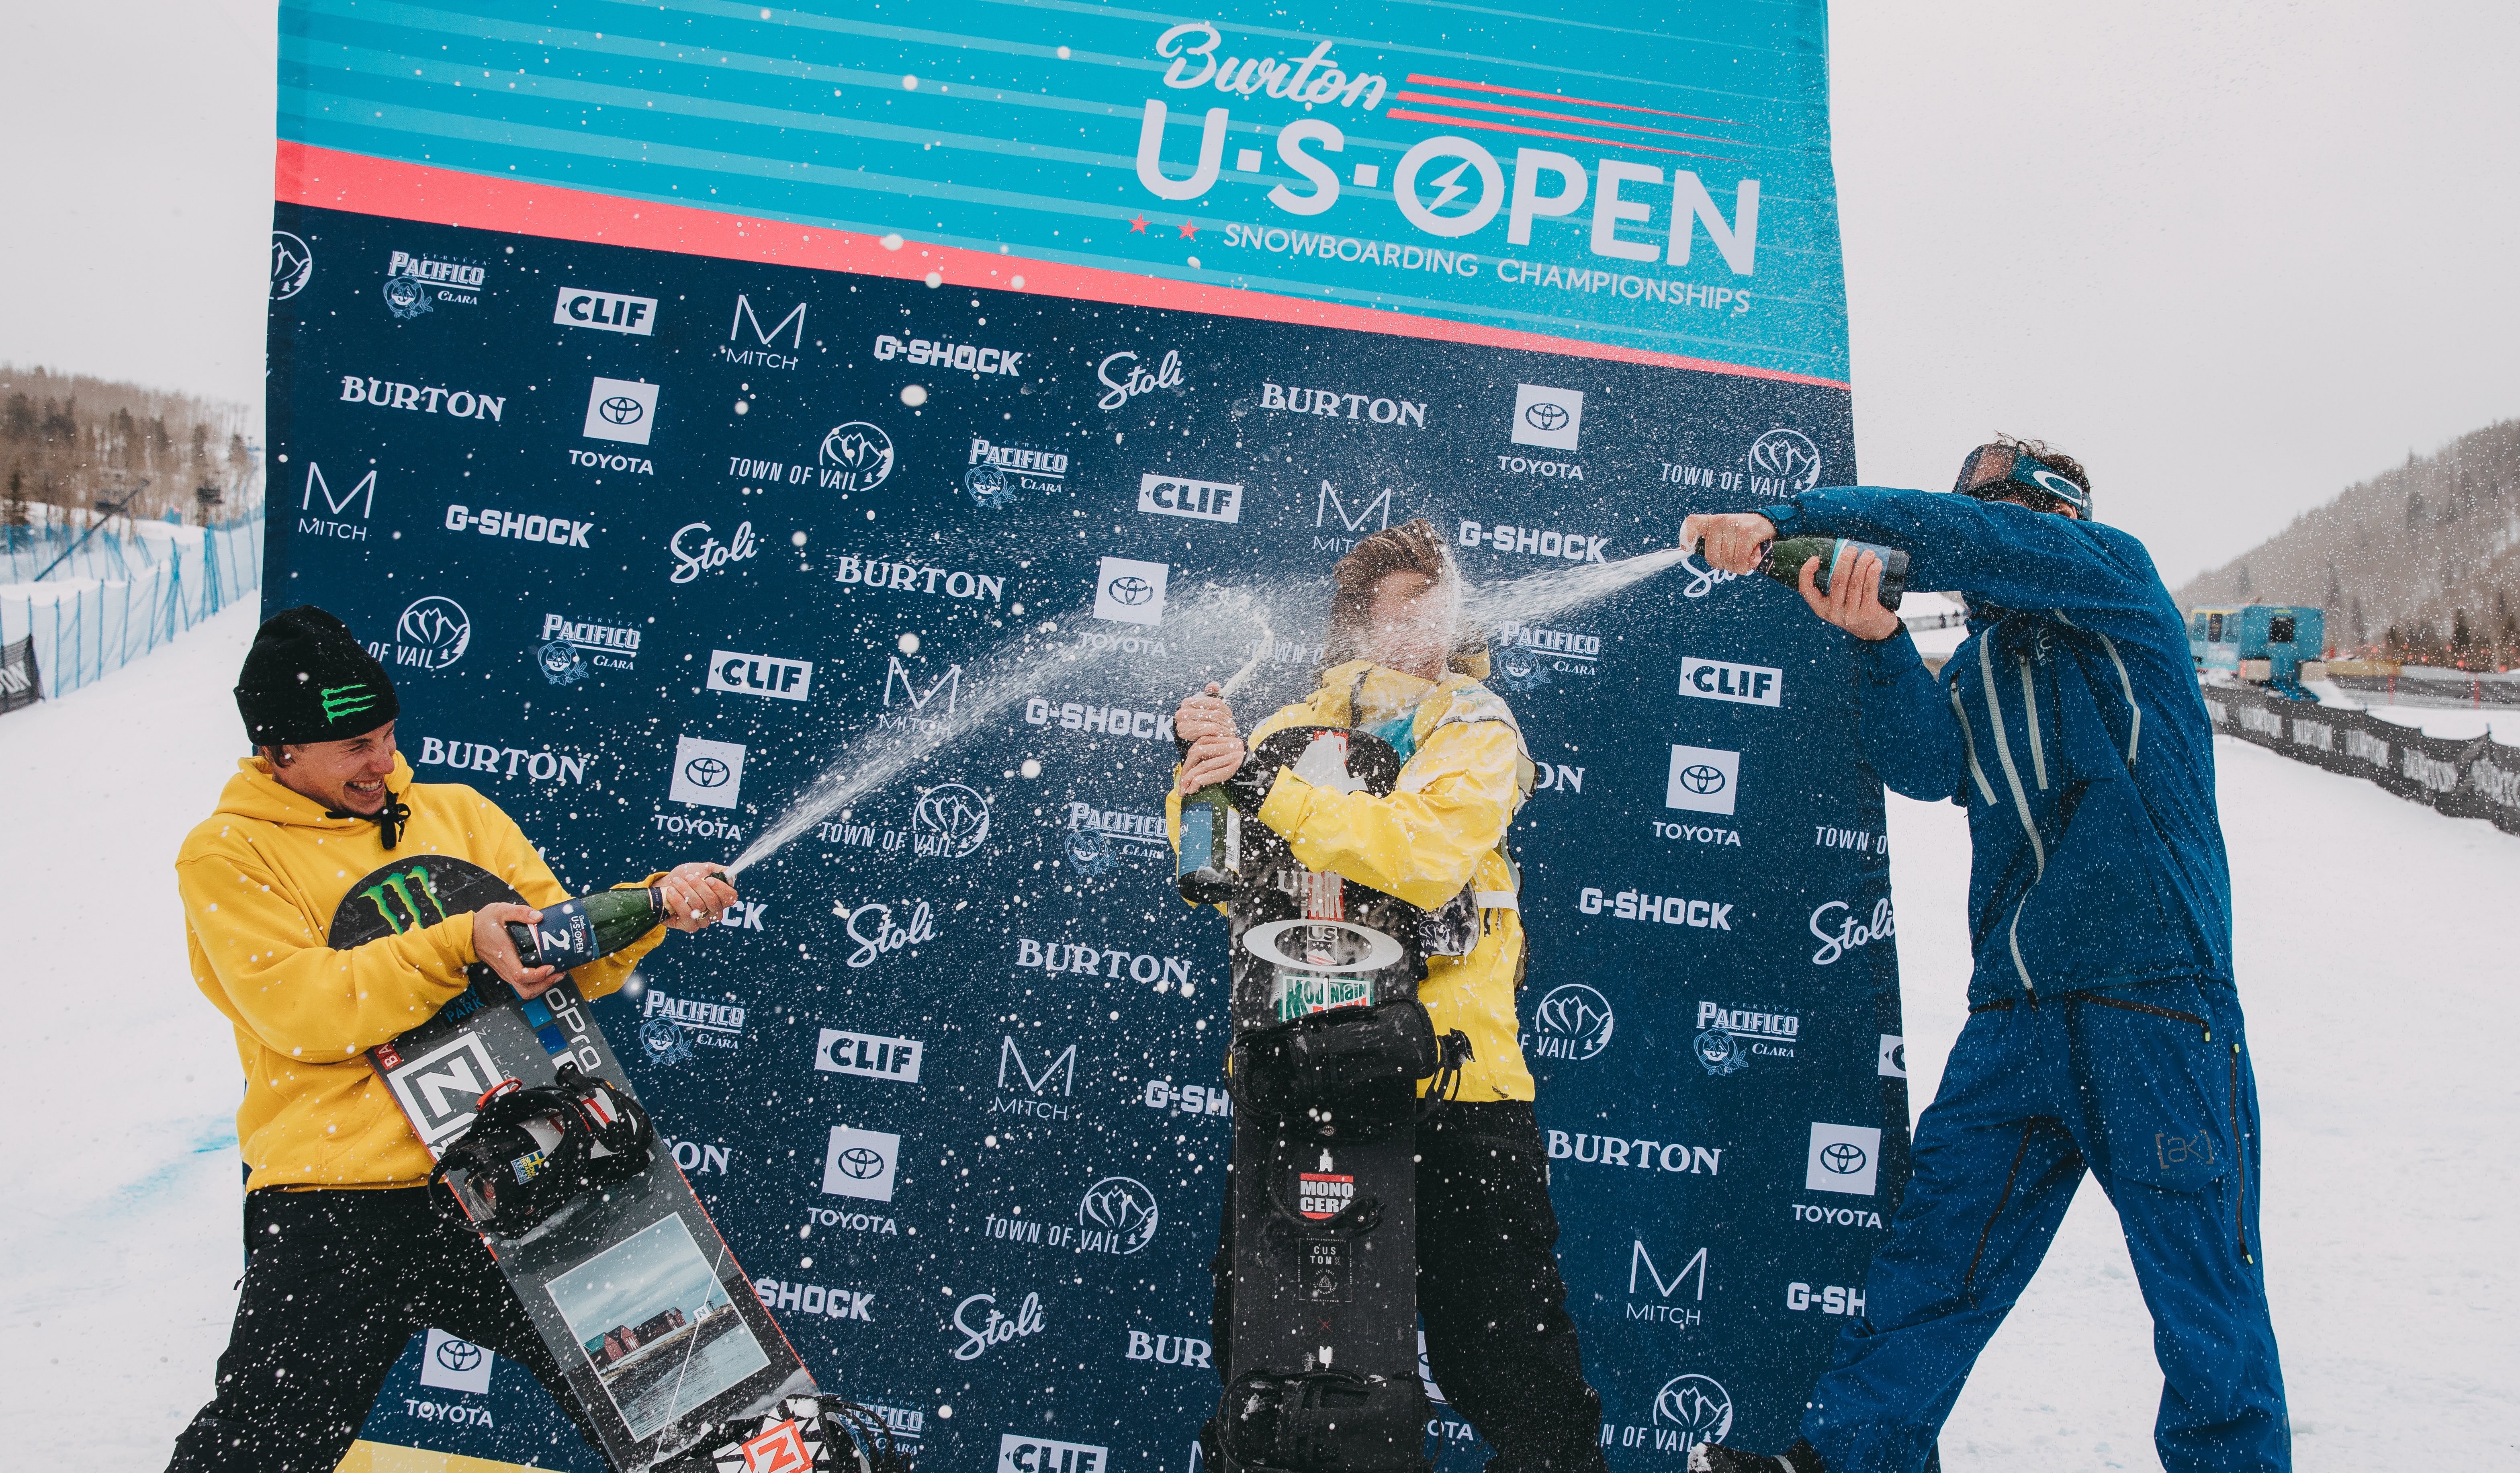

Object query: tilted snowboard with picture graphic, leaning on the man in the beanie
[327,855,857,1473]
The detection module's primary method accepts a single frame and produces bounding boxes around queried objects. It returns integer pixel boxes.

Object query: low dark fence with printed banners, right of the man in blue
[2205,686,2520,835]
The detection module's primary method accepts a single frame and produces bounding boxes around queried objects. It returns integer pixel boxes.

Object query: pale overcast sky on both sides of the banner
[0,0,2520,585]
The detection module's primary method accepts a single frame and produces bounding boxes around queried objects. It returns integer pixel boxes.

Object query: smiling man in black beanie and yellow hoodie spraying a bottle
[169,608,736,1473]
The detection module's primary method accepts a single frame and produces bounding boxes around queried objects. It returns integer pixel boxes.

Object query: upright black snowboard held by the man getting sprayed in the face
[1212,726,1477,1471]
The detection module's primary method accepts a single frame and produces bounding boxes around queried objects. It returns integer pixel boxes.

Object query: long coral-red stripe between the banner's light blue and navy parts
[272,141,1852,388]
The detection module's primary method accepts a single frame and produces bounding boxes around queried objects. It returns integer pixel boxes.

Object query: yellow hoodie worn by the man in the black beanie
[174,757,663,1188]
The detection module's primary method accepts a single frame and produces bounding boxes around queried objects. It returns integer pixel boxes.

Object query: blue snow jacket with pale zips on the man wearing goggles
[1759,487,2233,1006]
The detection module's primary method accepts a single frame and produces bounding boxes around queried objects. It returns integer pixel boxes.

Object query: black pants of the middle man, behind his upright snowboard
[1212,1100,1608,1473]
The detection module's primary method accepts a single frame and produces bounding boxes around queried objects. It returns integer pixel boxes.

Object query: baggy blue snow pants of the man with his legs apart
[1802,981,2293,1473]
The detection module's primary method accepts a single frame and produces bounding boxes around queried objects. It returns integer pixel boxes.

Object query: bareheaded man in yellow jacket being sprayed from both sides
[1164,520,1605,1473]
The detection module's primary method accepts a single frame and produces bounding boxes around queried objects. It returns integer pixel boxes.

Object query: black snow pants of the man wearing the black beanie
[166,1188,595,1473]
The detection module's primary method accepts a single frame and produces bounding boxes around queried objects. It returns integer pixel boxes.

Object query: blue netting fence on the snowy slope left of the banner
[0,507,262,696]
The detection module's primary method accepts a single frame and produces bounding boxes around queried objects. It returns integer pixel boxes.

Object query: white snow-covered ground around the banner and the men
[0,608,2520,1473]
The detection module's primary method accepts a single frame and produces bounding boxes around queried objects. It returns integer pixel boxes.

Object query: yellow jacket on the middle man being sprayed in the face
[1164,661,1532,1100]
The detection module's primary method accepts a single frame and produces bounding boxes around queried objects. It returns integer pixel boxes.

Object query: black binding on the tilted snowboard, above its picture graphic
[428,1064,655,1238]
